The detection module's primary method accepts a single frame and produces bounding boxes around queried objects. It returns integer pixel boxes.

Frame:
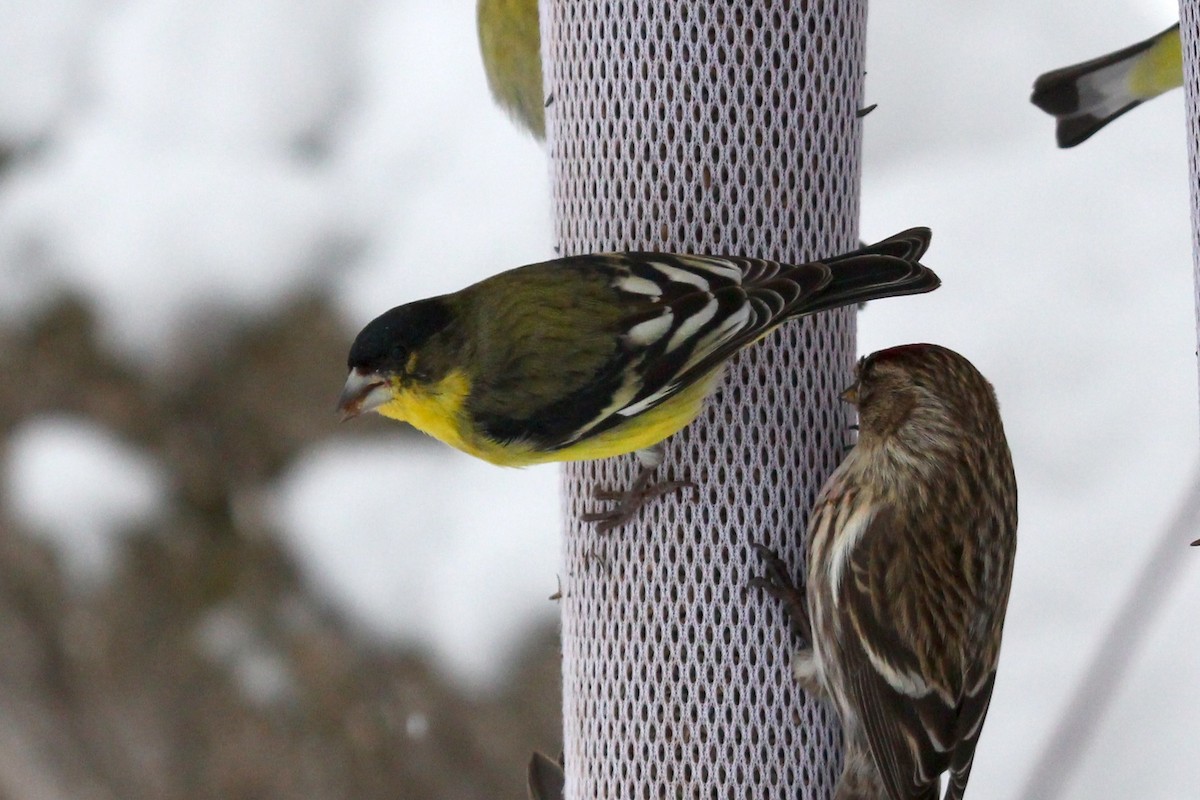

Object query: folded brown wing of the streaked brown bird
[836,507,996,800]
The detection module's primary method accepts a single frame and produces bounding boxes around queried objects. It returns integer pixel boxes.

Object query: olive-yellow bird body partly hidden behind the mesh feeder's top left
[475,0,546,139]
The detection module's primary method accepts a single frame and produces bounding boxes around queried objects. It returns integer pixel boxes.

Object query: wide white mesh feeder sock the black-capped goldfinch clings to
[541,0,864,800]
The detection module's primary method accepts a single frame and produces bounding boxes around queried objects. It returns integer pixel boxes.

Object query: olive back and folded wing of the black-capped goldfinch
[470,253,829,450]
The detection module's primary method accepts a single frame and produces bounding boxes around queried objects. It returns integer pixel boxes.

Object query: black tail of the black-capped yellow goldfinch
[790,228,942,315]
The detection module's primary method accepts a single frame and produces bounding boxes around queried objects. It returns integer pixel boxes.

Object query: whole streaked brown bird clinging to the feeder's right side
[755,344,1016,800]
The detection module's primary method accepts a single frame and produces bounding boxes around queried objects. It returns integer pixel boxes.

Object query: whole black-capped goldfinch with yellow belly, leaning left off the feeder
[338,228,940,528]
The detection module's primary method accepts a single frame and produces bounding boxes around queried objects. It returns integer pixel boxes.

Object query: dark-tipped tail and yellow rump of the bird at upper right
[1031,23,1183,148]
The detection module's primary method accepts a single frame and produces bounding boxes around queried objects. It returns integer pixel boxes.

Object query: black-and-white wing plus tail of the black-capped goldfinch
[476,235,938,450]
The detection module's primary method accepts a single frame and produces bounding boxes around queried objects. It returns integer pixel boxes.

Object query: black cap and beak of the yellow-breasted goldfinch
[337,297,452,422]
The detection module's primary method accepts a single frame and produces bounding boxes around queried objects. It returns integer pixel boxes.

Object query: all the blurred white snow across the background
[0,0,1200,799]
